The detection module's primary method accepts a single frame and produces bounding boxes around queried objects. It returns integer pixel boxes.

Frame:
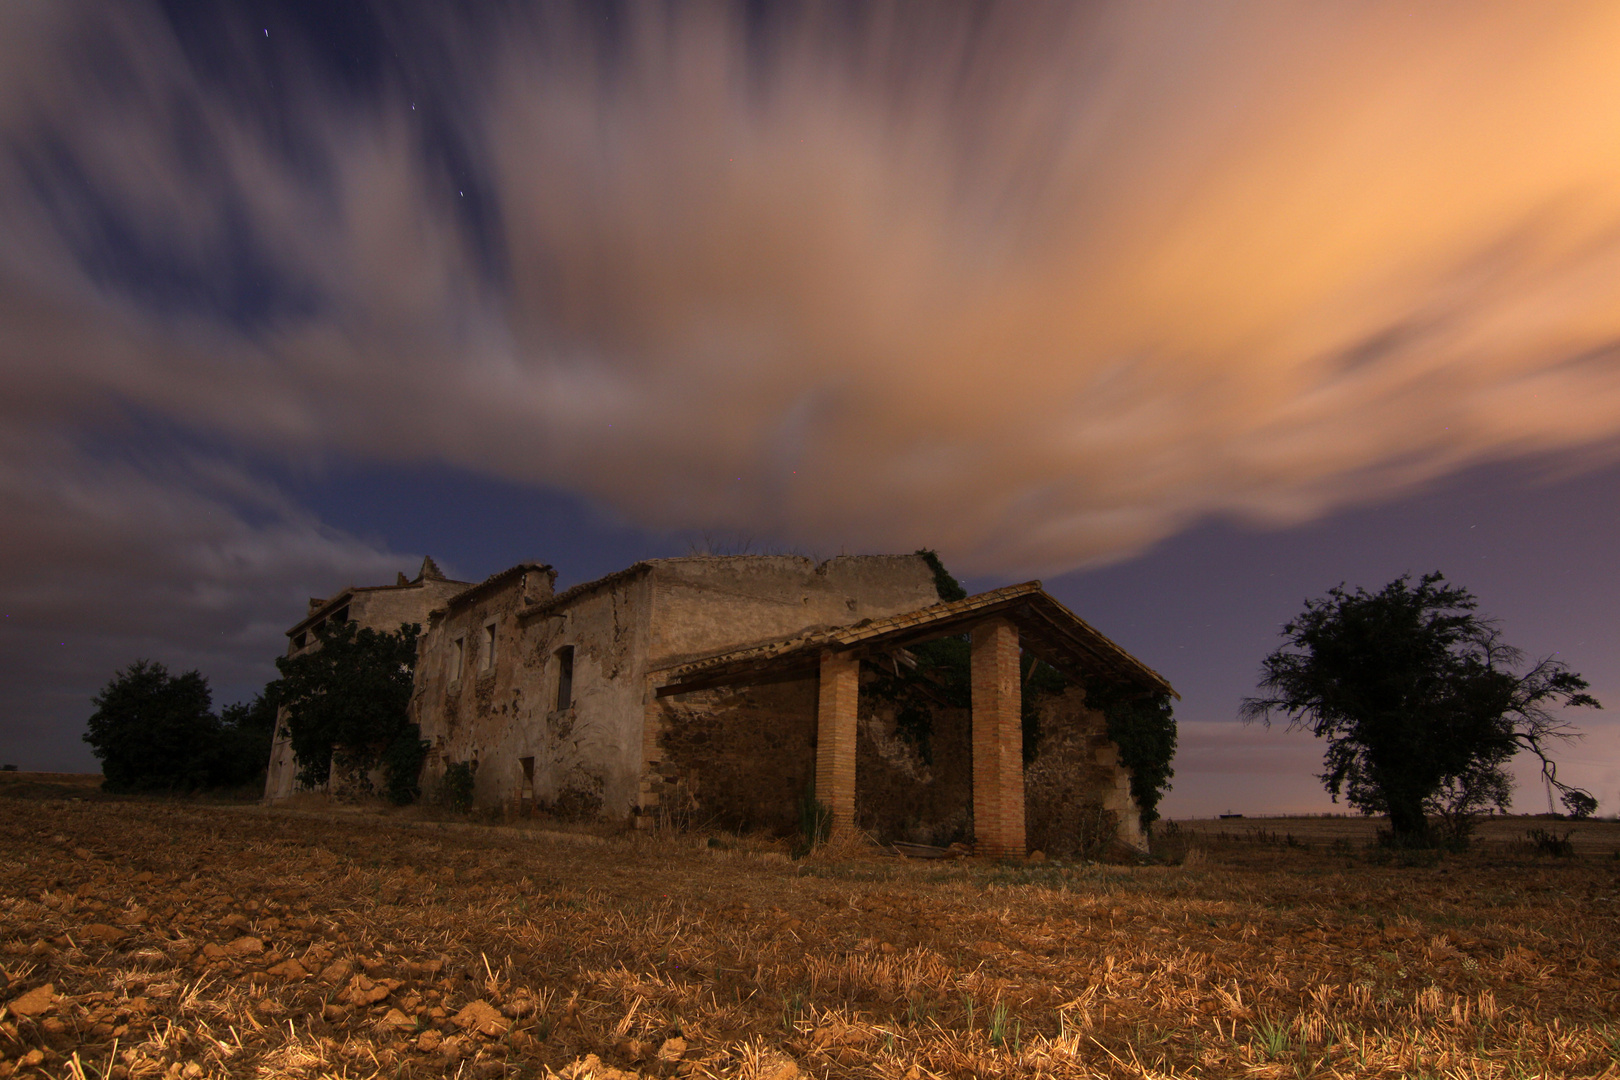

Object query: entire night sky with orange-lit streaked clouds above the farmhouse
[0,0,1620,816]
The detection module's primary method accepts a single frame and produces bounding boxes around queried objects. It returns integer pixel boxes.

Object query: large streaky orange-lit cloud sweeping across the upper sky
[9,3,1620,586]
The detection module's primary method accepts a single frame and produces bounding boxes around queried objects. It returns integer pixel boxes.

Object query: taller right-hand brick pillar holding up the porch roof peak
[972,619,1025,858]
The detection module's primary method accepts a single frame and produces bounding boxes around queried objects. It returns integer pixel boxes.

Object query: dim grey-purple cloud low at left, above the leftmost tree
[0,427,411,767]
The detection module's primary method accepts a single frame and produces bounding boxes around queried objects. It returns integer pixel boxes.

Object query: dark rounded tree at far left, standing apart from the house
[84,661,219,792]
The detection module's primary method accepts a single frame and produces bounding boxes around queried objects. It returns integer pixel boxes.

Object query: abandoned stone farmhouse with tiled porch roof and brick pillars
[266,555,1175,855]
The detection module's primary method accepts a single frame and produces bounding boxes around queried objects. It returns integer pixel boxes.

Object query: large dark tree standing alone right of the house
[1243,573,1601,845]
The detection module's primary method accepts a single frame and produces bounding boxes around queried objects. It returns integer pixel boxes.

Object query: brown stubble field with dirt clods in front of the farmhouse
[0,793,1620,1080]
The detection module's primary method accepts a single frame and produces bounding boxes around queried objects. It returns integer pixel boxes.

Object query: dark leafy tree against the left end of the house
[275,622,423,801]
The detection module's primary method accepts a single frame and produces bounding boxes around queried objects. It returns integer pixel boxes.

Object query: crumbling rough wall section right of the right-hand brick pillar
[1024,687,1147,857]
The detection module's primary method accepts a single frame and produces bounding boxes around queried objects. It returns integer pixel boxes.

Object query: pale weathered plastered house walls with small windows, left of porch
[411,555,938,819]
